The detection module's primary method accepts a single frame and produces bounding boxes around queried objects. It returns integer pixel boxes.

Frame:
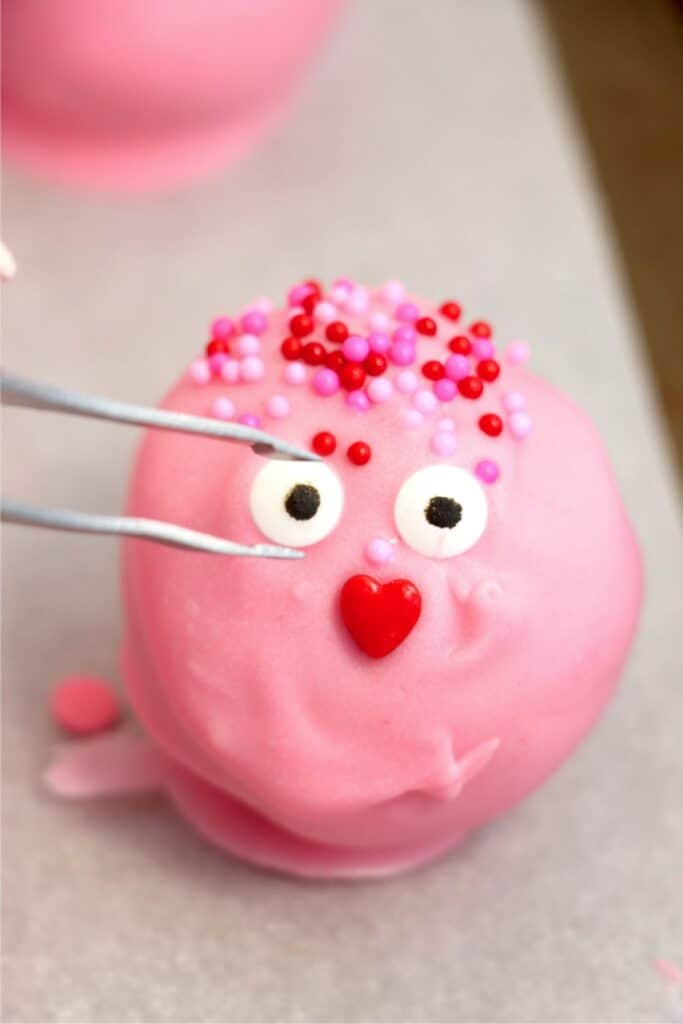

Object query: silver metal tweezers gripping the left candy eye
[0,373,319,558]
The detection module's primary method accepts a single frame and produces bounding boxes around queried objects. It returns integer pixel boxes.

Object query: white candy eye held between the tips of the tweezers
[249,460,344,548]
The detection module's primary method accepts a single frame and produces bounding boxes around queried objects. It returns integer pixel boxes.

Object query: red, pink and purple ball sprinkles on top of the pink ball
[189,278,531,484]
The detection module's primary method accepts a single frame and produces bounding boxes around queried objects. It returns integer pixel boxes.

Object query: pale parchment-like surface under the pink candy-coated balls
[2,0,683,1022]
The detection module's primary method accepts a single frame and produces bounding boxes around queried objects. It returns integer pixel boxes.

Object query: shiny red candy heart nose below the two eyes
[341,575,422,657]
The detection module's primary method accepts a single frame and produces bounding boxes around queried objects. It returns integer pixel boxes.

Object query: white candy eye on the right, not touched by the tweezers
[393,466,488,558]
